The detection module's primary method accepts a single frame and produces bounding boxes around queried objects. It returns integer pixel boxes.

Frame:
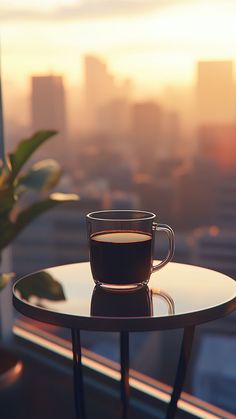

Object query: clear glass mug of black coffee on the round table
[86,210,174,289]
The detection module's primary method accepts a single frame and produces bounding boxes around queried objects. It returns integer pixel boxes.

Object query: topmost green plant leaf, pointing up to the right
[9,131,57,179]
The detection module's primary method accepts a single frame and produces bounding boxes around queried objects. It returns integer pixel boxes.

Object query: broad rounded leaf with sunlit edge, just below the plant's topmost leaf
[16,159,61,192]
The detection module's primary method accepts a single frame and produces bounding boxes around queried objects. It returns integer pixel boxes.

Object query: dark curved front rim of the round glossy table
[13,288,236,332]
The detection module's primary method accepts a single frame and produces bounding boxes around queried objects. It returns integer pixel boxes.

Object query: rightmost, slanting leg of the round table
[166,326,195,419]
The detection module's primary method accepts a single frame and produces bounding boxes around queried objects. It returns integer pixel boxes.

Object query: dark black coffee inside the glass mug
[90,230,152,285]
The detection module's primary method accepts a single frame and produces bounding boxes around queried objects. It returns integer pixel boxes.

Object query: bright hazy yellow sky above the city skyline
[0,0,236,90]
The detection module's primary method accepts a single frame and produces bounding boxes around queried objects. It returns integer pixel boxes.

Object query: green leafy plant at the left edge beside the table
[0,131,79,340]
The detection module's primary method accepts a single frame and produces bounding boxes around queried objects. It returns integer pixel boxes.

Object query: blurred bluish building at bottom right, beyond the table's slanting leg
[192,330,236,418]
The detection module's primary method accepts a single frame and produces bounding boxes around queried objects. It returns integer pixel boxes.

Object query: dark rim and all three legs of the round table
[13,263,236,419]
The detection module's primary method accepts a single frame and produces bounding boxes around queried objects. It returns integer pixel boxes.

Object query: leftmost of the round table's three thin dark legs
[71,329,86,419]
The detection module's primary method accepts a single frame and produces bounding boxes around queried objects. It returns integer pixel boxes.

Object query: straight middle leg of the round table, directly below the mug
[120,332,129,419]
